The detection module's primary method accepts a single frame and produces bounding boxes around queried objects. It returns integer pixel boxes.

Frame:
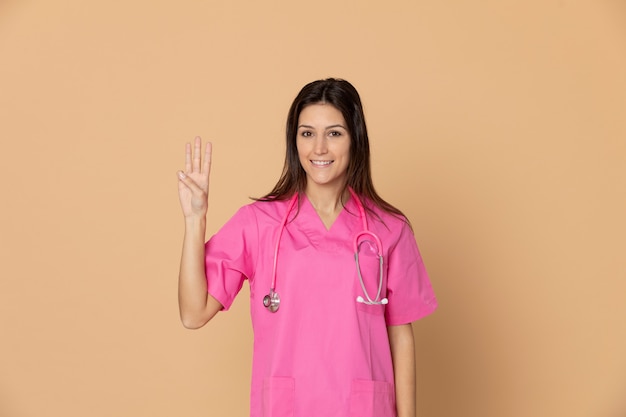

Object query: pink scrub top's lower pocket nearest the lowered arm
[350,380,396,417]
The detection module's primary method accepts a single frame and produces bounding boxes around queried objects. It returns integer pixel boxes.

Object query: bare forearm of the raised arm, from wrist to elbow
[178,214,221,329]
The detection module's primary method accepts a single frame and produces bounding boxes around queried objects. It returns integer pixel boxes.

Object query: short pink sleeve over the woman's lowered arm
[385,223,437,326]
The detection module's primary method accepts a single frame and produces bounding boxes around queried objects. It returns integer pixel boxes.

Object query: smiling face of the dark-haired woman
[296,103,351,189]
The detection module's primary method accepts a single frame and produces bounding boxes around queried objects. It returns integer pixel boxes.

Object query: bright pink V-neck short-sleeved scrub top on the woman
[206,196,437,417]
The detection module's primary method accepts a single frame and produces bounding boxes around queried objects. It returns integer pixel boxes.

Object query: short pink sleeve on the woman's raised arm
[204,206,258,310]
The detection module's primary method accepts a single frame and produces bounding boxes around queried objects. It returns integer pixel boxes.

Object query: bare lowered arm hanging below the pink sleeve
[387,324,416,417]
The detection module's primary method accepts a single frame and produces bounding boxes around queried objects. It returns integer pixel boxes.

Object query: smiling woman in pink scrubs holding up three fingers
[179,79,437,417]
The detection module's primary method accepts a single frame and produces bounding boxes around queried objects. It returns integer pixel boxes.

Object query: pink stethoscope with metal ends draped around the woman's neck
[263,187,389,313]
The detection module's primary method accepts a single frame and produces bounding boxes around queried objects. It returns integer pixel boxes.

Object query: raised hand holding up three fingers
[178,136,211,218]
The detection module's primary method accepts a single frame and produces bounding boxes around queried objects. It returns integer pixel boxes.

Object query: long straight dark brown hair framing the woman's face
[259,78,408,221]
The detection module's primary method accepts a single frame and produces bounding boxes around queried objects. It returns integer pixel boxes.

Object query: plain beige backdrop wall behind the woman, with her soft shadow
[0,0,626,417]
